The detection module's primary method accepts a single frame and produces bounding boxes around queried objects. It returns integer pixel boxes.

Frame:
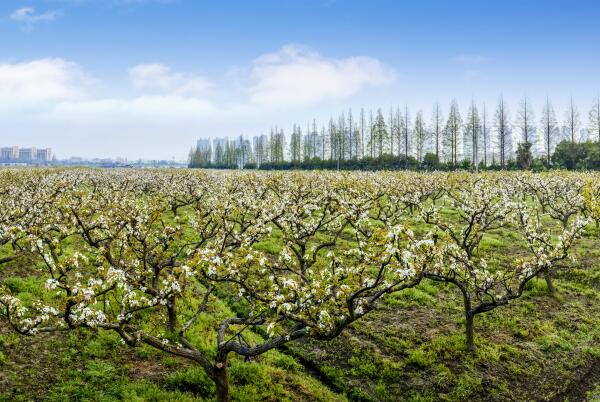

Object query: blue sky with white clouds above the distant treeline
[0,0,600,160]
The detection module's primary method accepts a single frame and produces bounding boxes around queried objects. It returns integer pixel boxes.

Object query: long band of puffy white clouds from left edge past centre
[0,45,395,119]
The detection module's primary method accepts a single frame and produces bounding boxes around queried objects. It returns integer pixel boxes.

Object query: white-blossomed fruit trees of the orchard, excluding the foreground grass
[0,169,600,400]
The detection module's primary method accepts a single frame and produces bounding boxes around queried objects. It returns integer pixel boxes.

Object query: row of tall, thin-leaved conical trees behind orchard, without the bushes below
[190,97,600,167]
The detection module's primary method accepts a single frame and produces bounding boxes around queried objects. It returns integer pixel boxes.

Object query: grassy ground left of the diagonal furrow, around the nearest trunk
[0,250,346,402]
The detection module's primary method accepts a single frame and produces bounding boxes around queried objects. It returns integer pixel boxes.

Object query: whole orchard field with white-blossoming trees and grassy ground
[0,169,600,401]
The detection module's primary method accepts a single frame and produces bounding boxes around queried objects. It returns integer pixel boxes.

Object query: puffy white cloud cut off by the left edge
[0,58,91,102]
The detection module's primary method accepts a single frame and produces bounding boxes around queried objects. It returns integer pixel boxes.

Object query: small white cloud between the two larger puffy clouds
[128,64,211,95]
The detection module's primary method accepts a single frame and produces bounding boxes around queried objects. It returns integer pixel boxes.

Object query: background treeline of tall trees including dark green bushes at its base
[189,97,600,170]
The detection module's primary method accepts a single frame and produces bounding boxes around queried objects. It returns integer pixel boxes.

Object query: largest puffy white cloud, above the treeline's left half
[250,45,395,108]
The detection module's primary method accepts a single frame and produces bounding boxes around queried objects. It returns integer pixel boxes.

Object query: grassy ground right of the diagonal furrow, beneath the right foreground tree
[284,225,600,402]
